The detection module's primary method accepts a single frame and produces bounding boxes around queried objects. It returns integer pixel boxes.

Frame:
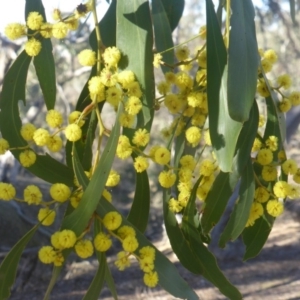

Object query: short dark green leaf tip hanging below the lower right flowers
[242,216,274,260]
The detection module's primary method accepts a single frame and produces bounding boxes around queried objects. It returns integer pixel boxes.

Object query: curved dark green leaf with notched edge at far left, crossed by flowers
[0,51,73,186]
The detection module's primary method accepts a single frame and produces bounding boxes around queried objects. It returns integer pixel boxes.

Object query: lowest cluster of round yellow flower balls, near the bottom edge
[38,211,159,287]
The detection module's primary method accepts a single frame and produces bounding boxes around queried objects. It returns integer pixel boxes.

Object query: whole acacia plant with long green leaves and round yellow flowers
[0,0,300,300]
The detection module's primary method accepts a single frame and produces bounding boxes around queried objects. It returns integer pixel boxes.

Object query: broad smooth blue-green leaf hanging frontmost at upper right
[227,0,259,122]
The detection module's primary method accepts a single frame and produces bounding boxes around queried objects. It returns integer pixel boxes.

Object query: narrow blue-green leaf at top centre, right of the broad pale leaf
[152,0,174,73]
